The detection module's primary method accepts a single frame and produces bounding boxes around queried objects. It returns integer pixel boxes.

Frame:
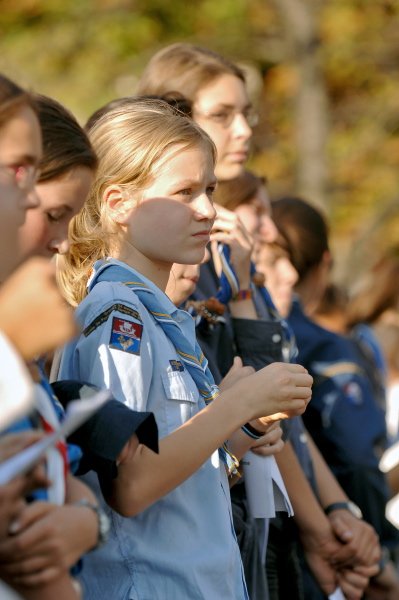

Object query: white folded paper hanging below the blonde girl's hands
[241,451,294,519]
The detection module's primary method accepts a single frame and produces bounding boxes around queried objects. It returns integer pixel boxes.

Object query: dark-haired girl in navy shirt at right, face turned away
[273,197,399,597]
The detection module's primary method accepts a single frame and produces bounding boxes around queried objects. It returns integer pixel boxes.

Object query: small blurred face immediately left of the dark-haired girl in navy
[256,244,298,317]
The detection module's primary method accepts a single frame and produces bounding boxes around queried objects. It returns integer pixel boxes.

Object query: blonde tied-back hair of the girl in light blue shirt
[58,98,216,306]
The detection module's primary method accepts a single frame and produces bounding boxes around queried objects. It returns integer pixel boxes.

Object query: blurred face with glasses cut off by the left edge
[0,106,42,282]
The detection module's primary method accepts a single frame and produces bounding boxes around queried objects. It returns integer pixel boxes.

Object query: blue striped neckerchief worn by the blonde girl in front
[88,261,239,474]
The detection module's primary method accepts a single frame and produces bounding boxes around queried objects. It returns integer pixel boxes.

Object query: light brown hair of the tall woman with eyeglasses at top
[137,43,245,102]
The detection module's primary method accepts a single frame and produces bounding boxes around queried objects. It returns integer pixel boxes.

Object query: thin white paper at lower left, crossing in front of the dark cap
[0,390,111,485]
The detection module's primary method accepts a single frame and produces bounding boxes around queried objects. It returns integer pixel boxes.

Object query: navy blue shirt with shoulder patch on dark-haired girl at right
[288,299,399,545]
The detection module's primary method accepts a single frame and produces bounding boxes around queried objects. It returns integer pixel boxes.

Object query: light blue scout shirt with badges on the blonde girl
[59,261,248,600]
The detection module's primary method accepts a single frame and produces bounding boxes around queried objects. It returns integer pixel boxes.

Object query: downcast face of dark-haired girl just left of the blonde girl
[18,167,93,257]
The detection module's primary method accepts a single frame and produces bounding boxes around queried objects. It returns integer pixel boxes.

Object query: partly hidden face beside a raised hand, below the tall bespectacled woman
[234,187,277,244]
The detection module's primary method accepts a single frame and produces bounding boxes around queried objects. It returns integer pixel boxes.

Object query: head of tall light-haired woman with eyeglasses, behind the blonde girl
[137,43,257,180]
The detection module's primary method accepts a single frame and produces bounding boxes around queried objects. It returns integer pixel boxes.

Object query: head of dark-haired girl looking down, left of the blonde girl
[19,96,97,258]
